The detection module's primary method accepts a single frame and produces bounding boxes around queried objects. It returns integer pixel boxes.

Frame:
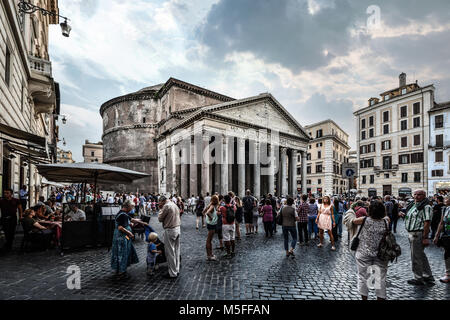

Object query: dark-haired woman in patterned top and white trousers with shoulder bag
[353,200,390,300]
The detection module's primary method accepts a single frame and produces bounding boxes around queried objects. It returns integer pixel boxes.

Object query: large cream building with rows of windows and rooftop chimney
[354,73,435,196]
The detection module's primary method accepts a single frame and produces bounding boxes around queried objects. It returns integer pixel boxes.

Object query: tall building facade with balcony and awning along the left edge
[0,0,60,204]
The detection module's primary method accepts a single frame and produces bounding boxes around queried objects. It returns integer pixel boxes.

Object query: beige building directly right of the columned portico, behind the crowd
[297,119,350,195]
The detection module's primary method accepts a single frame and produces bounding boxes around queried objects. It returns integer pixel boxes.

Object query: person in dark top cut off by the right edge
[433,196,450,283]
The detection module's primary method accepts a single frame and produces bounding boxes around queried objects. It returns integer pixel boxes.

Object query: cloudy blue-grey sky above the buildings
[49,0,450,161]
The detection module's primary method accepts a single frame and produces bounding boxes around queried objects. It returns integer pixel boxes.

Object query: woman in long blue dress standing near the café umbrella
[111,200,139,276]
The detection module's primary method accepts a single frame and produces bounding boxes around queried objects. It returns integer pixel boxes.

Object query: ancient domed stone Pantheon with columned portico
[100,78,310,197]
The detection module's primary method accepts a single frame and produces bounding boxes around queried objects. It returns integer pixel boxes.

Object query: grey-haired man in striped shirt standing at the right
[402,190,434,285]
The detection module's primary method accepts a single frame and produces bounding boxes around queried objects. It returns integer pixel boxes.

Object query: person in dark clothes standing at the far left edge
[0,188,23,252]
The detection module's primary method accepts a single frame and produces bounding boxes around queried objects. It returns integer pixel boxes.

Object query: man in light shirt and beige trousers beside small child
[158,196,181,279]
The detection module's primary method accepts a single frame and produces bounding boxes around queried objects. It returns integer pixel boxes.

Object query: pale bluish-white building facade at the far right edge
[428,101,450,195]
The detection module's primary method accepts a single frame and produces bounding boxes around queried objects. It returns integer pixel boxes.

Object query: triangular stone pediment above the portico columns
[203,94,309,139]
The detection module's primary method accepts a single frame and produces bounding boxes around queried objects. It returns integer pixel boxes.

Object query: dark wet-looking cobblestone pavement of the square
[0,215,450,300]
